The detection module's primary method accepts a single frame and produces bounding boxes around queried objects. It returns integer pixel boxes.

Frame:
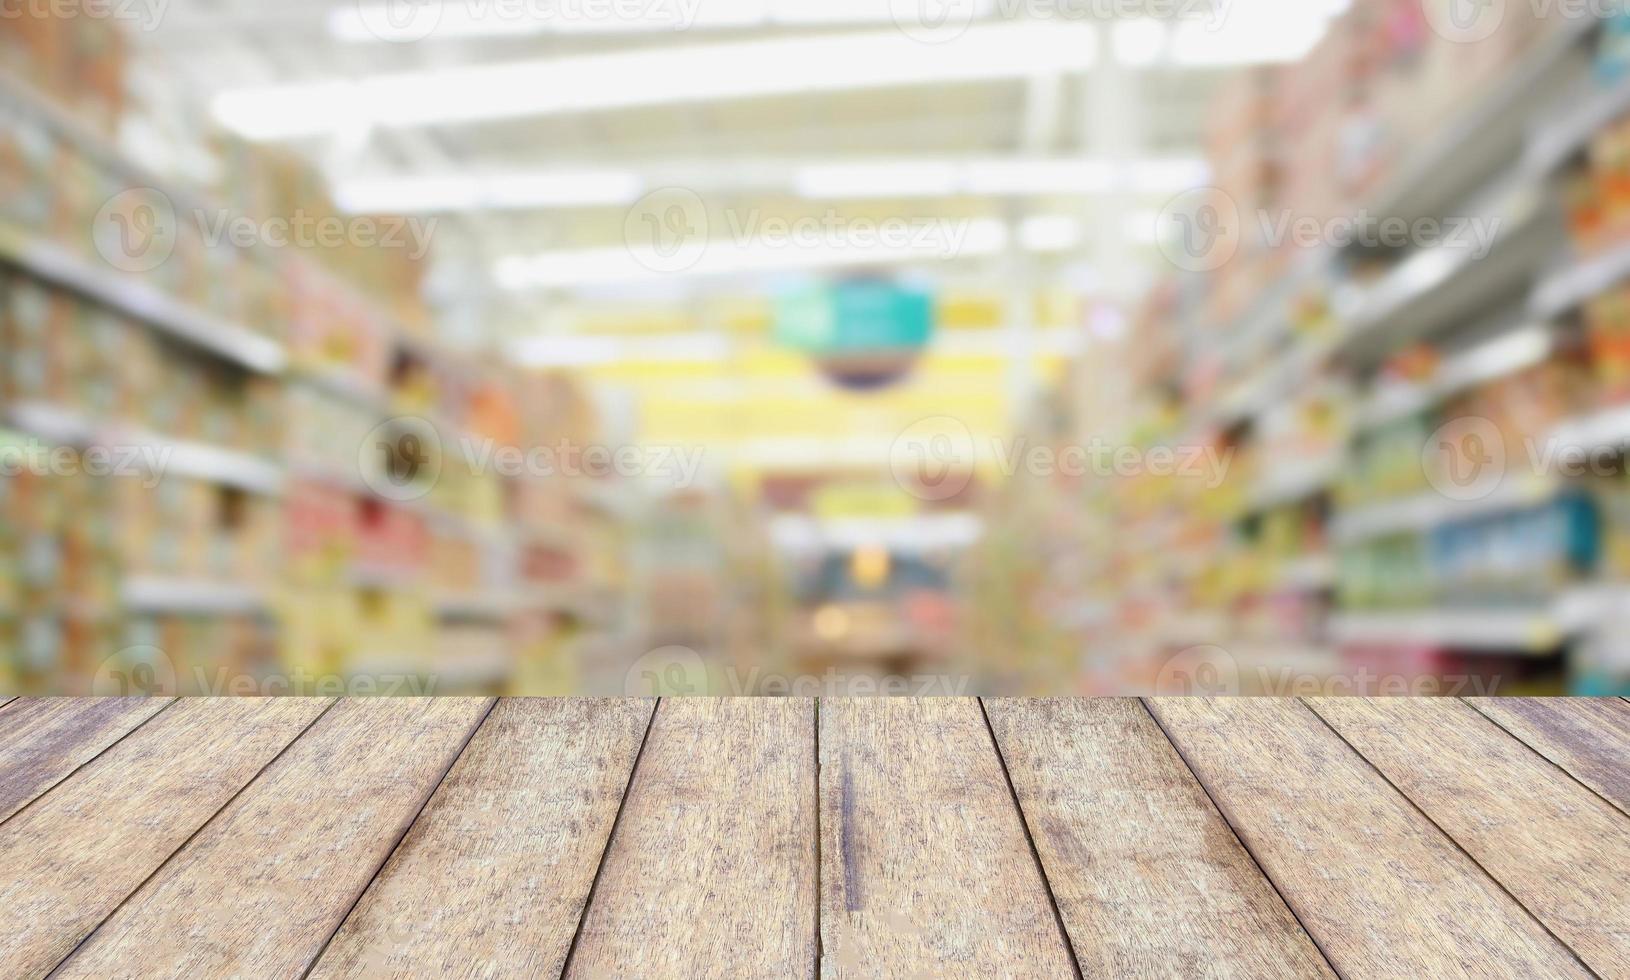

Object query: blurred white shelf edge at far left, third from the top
[5,401,284,496]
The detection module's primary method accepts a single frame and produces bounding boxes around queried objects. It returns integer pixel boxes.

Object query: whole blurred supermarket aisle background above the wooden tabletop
[9,0,1630,695]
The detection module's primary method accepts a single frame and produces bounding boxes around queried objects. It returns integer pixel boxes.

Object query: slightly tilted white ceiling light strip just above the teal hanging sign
[494,219,1007,290]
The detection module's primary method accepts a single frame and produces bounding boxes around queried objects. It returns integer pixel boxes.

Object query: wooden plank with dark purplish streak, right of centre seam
[820,698,1074,980]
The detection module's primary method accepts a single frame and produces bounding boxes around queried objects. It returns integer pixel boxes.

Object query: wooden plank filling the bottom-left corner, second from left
[0,700,329,977]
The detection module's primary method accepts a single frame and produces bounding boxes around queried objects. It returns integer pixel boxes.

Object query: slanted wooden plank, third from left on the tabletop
[55,698,491,978]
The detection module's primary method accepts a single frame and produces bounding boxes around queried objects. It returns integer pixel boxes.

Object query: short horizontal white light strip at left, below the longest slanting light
[334,171,645,214]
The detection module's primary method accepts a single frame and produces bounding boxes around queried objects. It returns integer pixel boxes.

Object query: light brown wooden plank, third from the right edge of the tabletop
[1149,698,1589,977]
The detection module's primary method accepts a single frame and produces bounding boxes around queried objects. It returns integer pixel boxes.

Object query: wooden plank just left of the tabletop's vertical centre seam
[567,698,817,980]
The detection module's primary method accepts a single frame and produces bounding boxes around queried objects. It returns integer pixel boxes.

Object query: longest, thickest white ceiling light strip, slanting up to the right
[214,21,1097,140]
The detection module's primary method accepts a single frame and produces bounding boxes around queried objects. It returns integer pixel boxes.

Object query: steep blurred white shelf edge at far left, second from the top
[0,223,287,375]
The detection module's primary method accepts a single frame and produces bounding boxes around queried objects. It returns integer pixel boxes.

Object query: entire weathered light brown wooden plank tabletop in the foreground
[0,700,1630,980]
